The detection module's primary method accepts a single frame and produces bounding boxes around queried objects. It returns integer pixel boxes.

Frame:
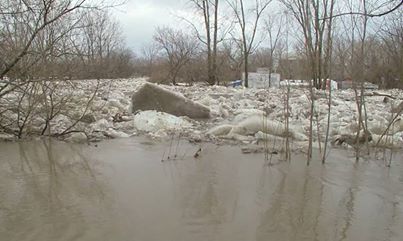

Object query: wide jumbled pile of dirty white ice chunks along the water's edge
[0,78,403,151]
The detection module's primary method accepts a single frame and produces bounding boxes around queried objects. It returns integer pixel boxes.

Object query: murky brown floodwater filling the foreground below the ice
[0,138,403,241]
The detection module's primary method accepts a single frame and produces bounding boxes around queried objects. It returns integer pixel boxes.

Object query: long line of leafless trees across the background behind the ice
[0,0,403,89]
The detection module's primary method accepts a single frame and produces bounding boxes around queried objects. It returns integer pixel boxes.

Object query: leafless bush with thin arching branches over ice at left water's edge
[0,80,99,138]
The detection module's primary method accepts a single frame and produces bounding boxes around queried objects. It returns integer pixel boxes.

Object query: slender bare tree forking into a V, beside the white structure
[227,0,271,87]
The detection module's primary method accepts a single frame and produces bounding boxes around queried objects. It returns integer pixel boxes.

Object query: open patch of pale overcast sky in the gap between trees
[115,0,186,52]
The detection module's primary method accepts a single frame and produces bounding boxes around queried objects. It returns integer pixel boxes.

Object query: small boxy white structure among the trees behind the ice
[242,68,280,89]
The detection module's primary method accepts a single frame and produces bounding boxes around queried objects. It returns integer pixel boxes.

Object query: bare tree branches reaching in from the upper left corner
[0,0,126,97]
